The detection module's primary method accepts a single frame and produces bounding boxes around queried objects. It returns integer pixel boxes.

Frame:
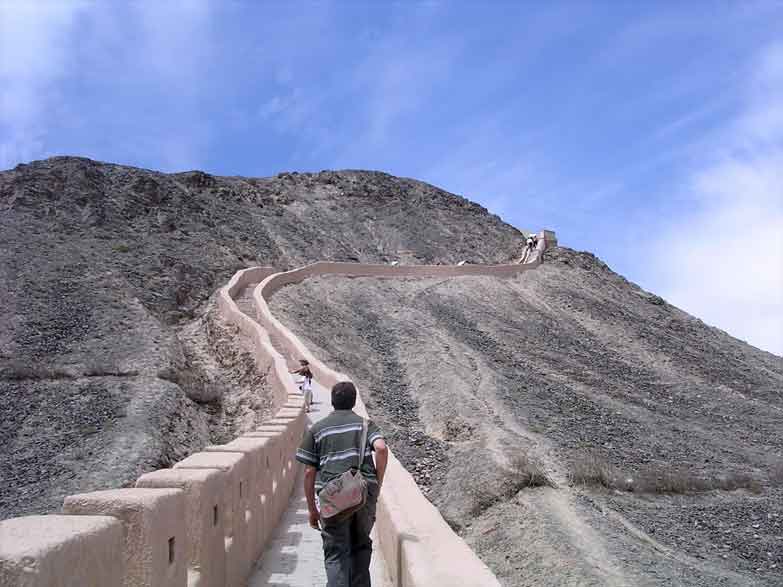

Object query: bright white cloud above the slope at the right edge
[655,45,783,354]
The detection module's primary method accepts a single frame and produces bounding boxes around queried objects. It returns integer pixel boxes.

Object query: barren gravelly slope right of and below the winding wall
[272,248,783,586]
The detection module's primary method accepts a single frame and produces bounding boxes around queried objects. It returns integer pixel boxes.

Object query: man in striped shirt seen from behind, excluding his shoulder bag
[296,381,389,587]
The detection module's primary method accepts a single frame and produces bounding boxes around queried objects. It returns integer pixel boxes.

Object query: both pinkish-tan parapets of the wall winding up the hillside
[0,231,556,587]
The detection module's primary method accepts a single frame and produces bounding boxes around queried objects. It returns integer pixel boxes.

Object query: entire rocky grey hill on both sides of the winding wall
[0,158,783,586]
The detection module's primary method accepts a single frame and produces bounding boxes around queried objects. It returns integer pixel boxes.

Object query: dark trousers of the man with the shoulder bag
[321,483,378,587]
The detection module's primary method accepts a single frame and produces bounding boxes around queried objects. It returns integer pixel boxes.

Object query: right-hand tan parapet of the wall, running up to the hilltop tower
[253,231,554,587]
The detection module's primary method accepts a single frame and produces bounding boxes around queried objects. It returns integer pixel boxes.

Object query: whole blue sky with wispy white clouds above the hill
[0,0,783,354]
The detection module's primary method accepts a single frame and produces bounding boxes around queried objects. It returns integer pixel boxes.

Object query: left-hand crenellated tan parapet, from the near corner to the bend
[0,267,306,587]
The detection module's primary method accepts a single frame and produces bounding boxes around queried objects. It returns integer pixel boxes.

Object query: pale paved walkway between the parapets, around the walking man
[248,381,391,587]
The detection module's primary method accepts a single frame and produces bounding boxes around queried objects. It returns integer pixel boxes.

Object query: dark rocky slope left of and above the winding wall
[0,157,522,519]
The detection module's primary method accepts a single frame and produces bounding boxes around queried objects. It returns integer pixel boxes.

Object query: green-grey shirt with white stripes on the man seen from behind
[296,410,383,491]
